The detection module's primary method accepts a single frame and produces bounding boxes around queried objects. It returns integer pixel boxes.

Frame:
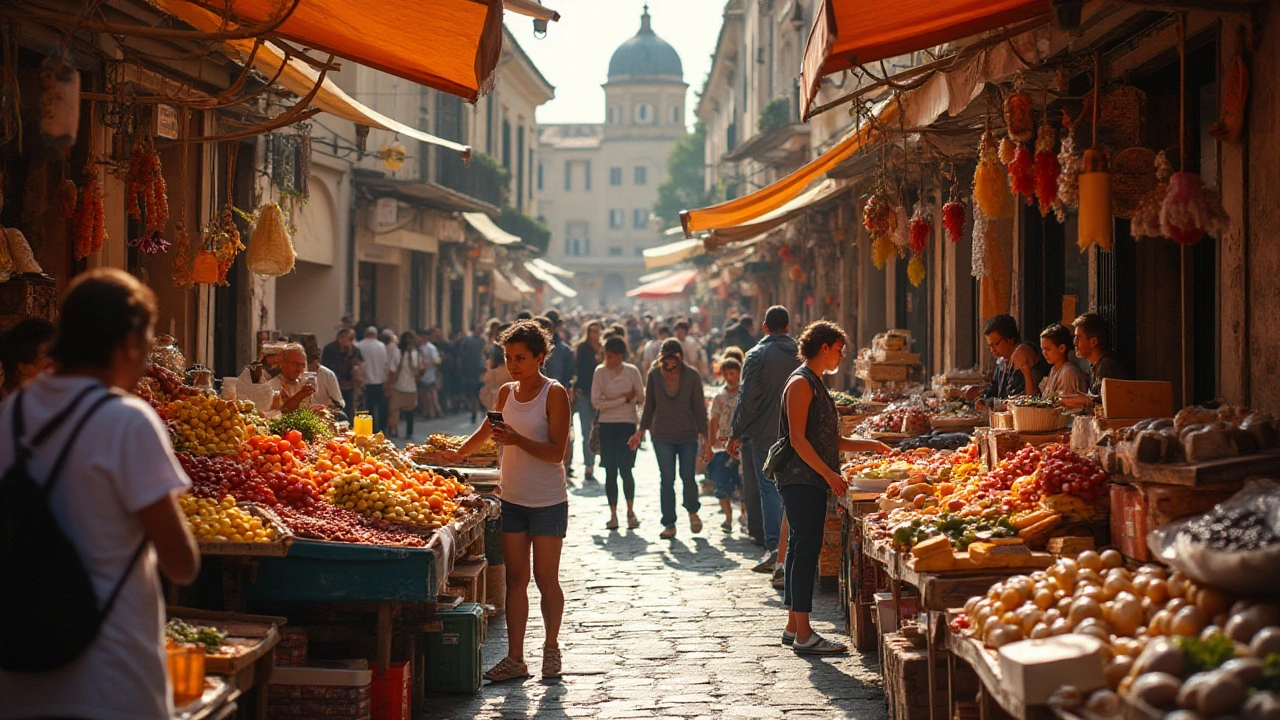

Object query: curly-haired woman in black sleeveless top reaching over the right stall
[774,320,888,655]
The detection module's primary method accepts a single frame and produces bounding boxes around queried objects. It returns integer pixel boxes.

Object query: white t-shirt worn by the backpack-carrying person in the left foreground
[0,375,191,720]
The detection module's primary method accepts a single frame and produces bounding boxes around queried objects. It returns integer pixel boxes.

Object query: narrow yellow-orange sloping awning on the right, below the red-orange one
[680,102,900,237]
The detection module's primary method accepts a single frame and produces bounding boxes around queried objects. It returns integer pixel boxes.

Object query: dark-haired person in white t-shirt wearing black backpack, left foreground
[0,269,200,720]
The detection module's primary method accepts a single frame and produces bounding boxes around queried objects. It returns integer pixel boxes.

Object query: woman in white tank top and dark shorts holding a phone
[448,320,571,682]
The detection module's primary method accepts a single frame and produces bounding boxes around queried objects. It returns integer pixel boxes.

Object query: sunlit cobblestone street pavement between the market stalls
[415,418,887,720]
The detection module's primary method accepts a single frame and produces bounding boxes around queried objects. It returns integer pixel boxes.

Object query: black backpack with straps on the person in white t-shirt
[0,386,146,673]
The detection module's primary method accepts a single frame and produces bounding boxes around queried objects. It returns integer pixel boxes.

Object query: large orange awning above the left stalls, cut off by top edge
[180,0,503,101]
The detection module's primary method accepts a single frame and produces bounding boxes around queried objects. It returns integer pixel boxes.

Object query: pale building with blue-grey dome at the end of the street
[538,8,689,307]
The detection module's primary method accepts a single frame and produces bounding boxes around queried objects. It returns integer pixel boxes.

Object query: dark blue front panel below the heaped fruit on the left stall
[244,539,439,602]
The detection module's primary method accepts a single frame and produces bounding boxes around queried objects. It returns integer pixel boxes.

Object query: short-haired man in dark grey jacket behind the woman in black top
[728,305,800,573]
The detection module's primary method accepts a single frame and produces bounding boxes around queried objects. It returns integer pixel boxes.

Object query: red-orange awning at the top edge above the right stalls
[800,0,1052,117]
